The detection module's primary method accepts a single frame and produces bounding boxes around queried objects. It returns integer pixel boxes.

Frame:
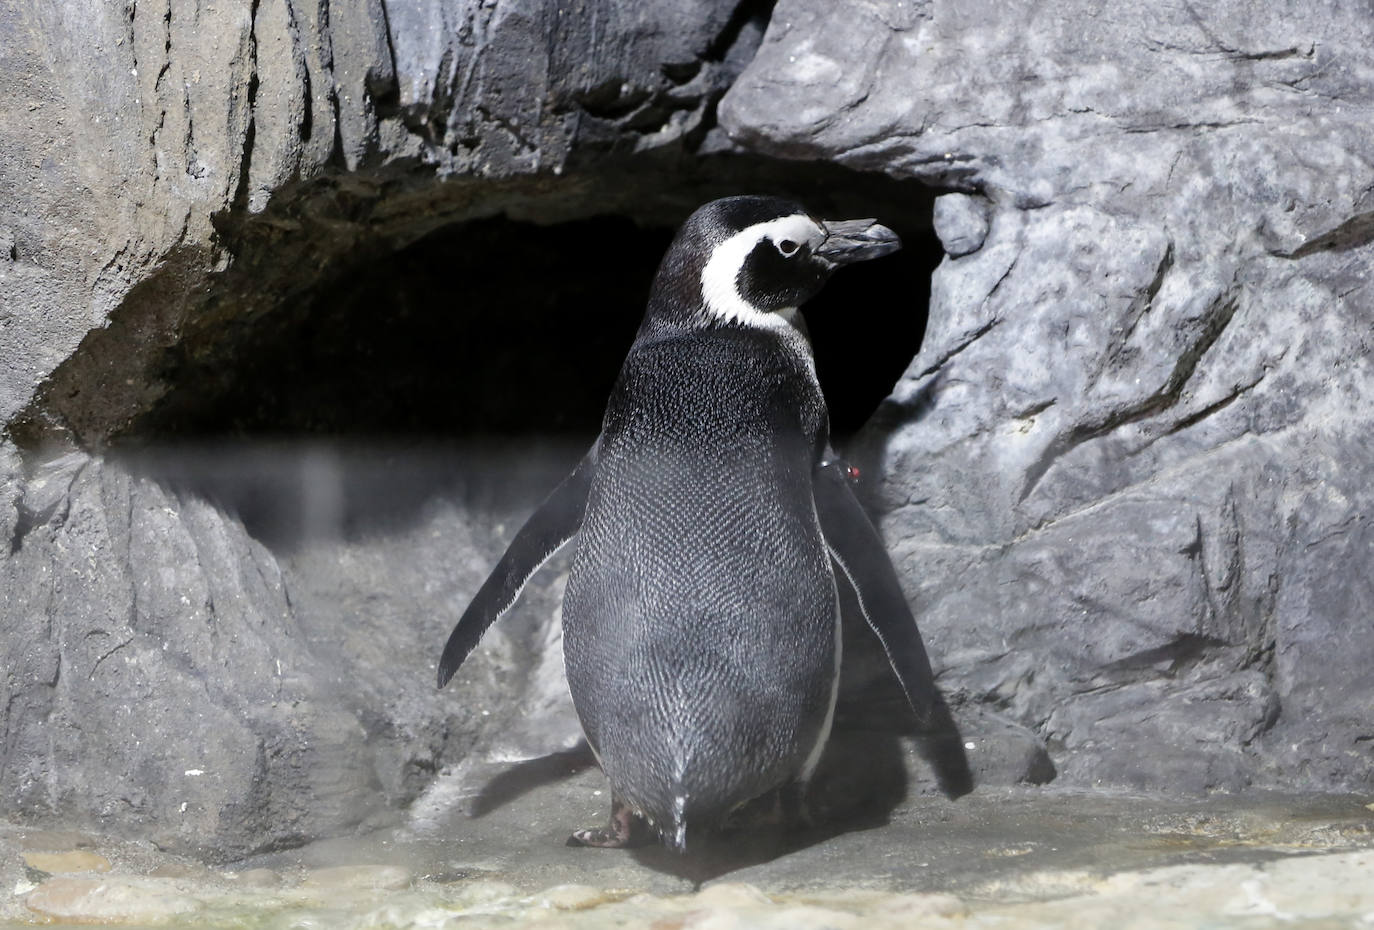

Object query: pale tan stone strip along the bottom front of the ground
[8,852,1374,930]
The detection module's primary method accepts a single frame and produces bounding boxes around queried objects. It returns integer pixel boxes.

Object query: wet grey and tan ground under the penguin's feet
[0,761,1374,930]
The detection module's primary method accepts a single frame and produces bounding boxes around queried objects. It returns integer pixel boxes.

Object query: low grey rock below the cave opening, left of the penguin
[0,442,574,860]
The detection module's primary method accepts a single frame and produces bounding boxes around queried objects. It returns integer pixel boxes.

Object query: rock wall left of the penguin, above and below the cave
[0,0,761,860]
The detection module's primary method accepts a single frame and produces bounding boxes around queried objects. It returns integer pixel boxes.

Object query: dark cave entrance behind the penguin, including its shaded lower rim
[109,159,943,547]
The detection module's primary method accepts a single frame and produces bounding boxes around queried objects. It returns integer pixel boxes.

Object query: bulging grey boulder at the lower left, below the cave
[3,457,348,857]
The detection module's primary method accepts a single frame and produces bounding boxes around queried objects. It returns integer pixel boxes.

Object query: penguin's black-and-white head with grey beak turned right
[650,196,901,328]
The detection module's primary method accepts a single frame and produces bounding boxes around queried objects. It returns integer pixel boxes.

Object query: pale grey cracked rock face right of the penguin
[721,0,1374,790]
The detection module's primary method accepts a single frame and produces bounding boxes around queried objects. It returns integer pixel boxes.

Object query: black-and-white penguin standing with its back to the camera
[438,196,938,852]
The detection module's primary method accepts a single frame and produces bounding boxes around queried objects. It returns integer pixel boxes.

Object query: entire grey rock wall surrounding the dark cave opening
[0,0,1374,859]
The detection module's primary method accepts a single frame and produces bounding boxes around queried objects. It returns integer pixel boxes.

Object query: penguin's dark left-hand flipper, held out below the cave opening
[438,441,600,688]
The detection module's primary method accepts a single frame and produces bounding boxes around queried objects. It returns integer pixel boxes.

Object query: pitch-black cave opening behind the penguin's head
[132,185,941,442]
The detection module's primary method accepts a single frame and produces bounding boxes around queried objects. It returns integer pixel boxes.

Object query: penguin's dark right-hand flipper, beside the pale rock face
[815,451,940,727]
